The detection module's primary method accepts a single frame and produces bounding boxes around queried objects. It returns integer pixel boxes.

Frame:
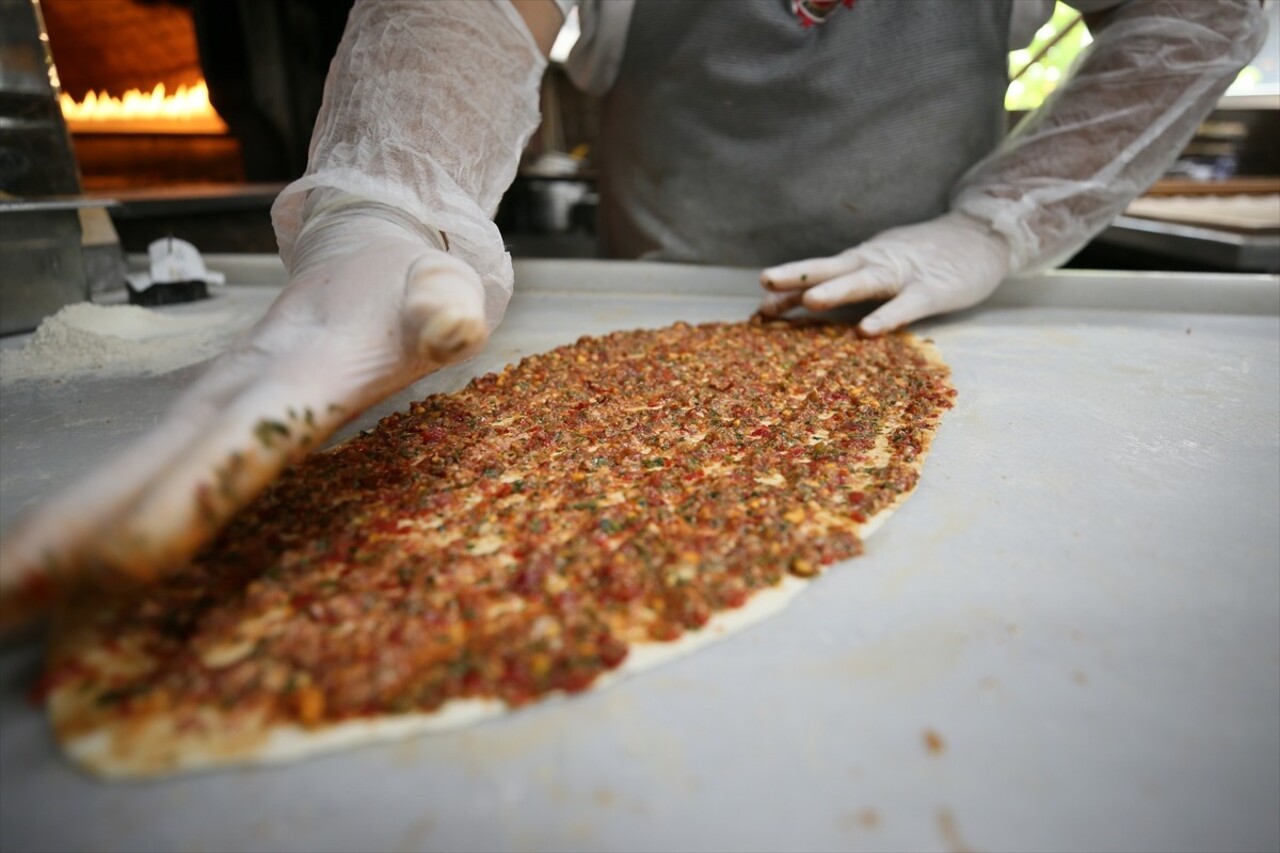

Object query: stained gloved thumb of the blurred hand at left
[404,252,489,365]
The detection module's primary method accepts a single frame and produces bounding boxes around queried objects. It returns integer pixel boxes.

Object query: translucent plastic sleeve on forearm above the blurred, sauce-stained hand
[271,0,547,328]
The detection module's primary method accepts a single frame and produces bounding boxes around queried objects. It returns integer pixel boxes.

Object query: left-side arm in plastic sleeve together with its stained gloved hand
[0,0,559,629]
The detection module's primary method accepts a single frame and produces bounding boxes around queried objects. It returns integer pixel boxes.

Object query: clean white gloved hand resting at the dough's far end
[760,213,1010,336]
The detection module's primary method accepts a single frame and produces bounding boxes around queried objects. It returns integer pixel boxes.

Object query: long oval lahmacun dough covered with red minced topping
[42,320,955,776]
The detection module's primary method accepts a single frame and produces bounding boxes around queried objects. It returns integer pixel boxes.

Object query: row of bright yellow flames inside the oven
[60,81,227,133]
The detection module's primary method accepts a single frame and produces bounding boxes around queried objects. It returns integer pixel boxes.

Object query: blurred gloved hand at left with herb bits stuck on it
[0,205,489,607]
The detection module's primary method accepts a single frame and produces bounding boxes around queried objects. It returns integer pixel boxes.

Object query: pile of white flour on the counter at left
[0,302,247,383]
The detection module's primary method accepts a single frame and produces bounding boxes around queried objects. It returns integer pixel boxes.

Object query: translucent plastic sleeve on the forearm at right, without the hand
[952,0,1266,273]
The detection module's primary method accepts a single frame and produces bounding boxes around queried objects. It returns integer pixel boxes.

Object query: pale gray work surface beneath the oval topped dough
[0,259,1280,850]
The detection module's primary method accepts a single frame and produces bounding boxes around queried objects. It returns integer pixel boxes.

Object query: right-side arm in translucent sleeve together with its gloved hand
[760,0,1266,334]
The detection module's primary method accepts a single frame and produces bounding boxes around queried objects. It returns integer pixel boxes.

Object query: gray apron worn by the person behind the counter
[595,0,1010,266]
